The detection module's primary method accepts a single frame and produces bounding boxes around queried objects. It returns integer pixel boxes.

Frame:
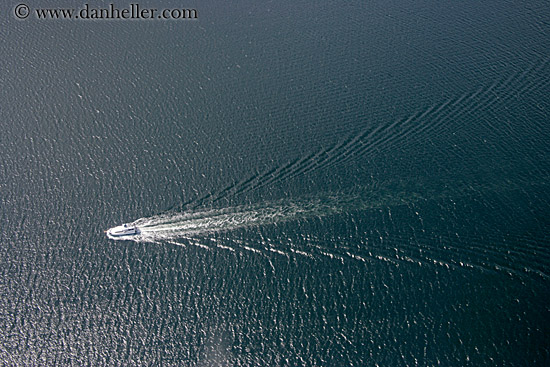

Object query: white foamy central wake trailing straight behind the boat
[111,170,547,247]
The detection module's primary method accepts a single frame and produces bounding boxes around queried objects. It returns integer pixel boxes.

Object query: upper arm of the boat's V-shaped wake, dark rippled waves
[182,59,550,209]
